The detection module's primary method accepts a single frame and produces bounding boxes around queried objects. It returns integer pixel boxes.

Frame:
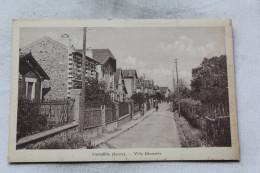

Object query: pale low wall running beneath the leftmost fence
[16,122,78,149]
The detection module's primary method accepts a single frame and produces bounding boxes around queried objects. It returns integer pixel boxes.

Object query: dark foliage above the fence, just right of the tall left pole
[85,77,113,107]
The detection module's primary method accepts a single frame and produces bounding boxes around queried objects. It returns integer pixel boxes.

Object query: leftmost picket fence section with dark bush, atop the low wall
[17,98,74,140]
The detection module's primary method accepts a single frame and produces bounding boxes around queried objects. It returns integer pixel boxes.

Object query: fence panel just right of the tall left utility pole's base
[83,108,102,129]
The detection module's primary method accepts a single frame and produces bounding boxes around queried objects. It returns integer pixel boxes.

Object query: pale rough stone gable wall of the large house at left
[21,37,69,99]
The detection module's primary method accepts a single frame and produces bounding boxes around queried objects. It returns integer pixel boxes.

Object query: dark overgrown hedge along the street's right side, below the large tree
[173,98,231,147]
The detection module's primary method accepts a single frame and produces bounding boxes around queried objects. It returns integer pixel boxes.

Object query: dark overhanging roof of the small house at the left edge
[19,52,50,80]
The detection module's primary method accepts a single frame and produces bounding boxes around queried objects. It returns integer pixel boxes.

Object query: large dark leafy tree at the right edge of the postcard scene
[191,55,229,117]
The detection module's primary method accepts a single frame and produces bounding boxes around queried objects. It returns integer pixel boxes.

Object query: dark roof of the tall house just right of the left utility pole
[92,49,116,64]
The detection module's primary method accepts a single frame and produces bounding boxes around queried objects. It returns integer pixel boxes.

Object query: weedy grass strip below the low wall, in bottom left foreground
[26,131,84,149]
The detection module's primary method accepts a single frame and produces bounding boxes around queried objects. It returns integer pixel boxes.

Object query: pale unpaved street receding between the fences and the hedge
[99,103,181,149]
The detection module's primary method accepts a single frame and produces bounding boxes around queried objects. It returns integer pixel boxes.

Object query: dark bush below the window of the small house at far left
[17,97,47,140]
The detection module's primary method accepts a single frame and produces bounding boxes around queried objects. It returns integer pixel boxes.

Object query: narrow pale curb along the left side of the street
[92,109,155,147]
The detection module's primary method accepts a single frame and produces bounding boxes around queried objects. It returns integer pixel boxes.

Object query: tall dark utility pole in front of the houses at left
[79,27,87,132]
